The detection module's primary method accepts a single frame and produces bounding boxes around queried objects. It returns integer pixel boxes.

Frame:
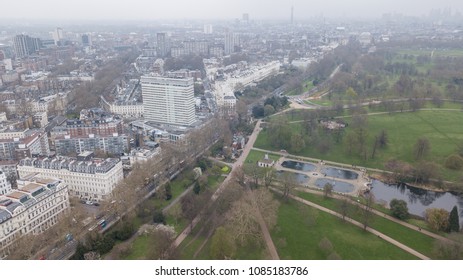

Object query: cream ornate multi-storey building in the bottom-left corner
[0,177,69,258]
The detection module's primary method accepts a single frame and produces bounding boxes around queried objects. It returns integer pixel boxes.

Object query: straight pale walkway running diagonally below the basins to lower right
[271,188,430,260]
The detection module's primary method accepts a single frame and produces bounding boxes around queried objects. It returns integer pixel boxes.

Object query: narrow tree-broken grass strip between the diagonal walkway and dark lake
[297,192,435,256]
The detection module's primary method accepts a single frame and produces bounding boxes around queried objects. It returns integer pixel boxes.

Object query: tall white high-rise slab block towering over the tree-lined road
[141,76,196,126]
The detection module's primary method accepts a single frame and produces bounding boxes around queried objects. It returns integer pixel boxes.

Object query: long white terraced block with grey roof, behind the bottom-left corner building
[18,157,124,201]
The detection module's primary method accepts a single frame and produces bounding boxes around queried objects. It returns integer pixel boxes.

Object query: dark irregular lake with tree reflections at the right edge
[371,180,463,222]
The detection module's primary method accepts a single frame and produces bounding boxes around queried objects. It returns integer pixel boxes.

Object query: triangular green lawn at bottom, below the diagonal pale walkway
[271,198,416,260]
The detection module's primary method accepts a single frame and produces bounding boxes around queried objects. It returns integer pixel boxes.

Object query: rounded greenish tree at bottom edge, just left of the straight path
[209,227,236,260]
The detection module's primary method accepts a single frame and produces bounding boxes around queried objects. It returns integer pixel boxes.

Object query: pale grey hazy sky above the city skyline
[2,0,463,20]
